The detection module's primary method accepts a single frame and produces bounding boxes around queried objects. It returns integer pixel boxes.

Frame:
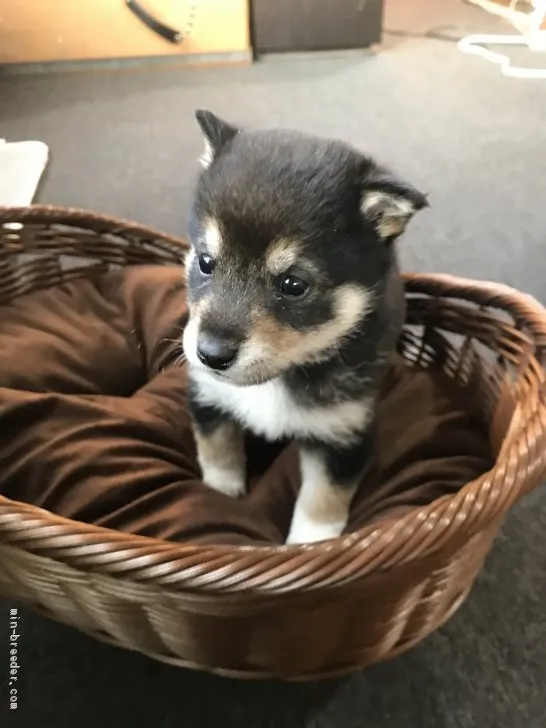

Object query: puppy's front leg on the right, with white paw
[286,429,373,543]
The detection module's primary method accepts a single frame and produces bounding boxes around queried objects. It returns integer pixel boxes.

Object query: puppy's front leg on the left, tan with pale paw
[190,390,246,498]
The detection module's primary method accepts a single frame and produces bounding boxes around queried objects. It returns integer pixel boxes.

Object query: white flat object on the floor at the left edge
[0,139,49,207]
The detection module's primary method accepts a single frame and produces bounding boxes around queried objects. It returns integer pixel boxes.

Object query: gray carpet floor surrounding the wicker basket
[0,2,546,728]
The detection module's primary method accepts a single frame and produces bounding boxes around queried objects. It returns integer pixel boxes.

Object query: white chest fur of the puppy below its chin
[188,370,371,443]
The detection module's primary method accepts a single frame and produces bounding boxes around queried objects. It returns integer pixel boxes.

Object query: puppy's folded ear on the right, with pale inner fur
[360,177,428,241]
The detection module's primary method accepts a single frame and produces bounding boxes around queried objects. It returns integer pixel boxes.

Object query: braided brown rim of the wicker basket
[0,205,546,595]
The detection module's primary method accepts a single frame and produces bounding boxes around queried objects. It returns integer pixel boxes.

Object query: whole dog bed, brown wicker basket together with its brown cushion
[0,206,546,678]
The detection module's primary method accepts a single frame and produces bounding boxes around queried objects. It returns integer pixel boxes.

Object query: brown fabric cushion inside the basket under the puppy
[0,267,491,544]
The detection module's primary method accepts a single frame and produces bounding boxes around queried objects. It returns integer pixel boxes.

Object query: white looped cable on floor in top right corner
[457,0,546,79]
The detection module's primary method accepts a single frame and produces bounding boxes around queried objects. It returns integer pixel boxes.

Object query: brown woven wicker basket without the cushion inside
[0,206,546,679]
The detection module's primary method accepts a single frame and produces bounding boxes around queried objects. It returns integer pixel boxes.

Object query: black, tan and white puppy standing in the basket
[183,111,427,543]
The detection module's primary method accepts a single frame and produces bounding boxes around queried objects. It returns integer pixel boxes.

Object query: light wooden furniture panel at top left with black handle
[0,0,250,64]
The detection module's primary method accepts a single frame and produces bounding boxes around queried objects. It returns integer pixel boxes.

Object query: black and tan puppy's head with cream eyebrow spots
[184,111,426,385]
